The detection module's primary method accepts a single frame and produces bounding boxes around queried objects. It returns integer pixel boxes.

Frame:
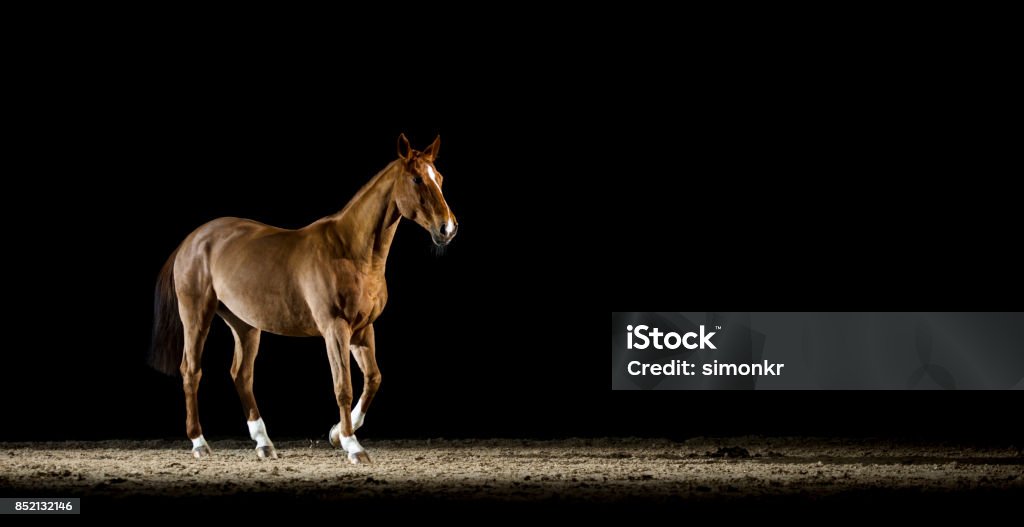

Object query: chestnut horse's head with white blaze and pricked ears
[394,134,459,247]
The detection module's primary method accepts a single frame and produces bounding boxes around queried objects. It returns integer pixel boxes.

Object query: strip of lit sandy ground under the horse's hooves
[0,437,1024,511]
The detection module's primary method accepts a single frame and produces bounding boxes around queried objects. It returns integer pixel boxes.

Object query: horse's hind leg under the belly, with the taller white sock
[217,306,278,459]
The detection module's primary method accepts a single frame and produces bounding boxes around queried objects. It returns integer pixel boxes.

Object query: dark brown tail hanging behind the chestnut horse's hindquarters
[150,249,185,376]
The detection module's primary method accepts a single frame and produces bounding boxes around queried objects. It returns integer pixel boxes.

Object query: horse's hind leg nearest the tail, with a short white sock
[177,287,217,458]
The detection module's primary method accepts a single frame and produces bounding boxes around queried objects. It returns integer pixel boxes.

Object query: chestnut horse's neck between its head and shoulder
[324,162,401,272]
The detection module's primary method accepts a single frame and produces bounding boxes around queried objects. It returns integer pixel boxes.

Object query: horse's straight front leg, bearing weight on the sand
[323,318,370,465]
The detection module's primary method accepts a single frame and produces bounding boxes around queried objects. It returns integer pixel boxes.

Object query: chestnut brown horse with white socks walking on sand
[151,134,459,464]
